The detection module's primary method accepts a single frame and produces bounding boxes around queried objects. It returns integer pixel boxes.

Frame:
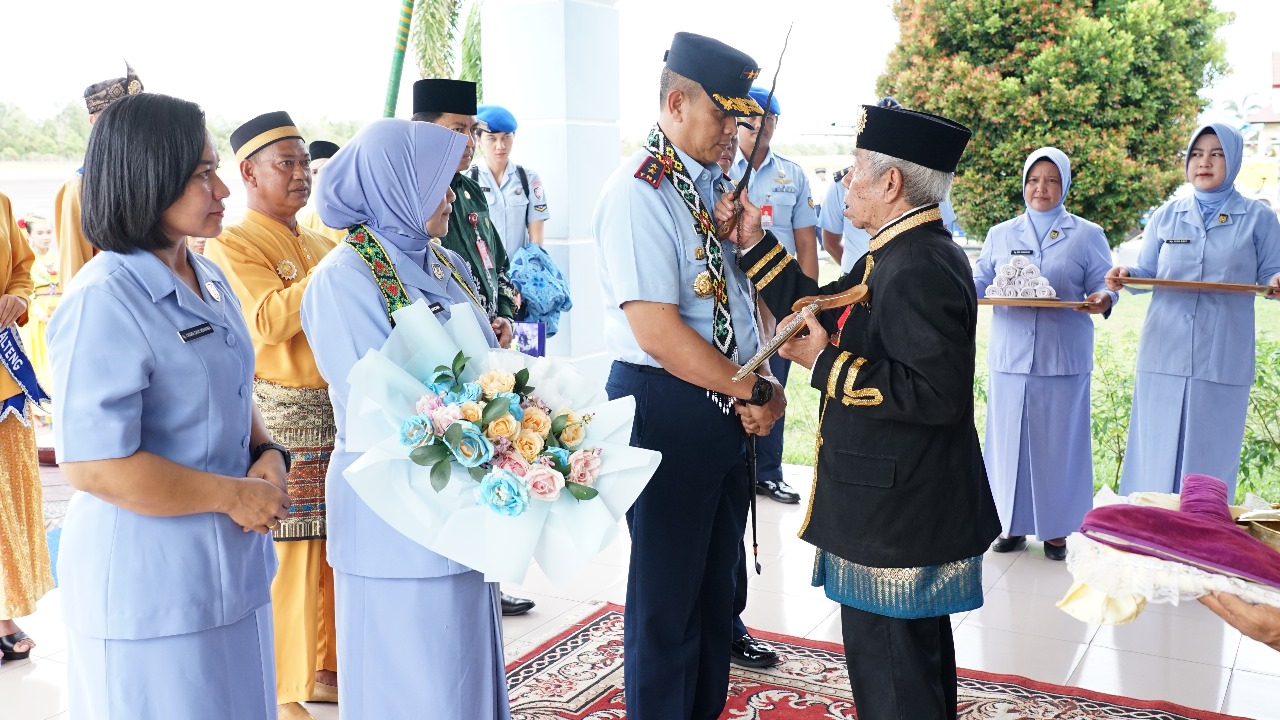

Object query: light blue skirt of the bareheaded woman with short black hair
[67,605,275,720]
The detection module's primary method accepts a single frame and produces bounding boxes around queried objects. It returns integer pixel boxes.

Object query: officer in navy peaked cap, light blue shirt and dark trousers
[591,32,785,720]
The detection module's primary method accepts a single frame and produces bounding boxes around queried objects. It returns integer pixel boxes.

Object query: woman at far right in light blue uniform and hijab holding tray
[1107,123,1280,498]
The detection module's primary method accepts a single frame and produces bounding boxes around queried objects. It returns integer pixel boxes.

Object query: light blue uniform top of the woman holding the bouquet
[302,238,498,578]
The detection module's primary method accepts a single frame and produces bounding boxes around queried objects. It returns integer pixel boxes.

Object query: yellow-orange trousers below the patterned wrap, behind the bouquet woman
[271,539,338,705]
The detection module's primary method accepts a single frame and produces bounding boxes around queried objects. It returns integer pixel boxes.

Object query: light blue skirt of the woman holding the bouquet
[333,570,511,720]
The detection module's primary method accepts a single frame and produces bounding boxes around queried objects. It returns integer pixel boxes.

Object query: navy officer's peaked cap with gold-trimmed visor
[663,32,764,118]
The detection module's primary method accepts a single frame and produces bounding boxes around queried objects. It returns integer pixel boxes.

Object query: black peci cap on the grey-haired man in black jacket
[854,105,973,173]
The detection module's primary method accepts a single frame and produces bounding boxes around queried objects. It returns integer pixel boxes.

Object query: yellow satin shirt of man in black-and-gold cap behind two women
[205,210,334,388]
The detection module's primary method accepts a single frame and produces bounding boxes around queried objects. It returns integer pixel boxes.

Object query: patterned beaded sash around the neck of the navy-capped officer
[636,126,737,414]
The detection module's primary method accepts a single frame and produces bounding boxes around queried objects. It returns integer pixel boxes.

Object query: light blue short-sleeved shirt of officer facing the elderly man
[591,149,759,366]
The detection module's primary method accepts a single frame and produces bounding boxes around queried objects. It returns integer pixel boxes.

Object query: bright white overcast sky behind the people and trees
[0,0,1280,142]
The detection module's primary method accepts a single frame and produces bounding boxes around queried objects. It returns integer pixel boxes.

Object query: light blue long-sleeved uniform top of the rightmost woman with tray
[1129,192,1280,386]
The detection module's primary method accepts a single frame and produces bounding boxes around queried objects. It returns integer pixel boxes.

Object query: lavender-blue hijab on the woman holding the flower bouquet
[316,118,467,251]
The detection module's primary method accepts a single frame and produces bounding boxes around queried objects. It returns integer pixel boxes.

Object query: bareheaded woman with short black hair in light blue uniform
[49,94,289,720]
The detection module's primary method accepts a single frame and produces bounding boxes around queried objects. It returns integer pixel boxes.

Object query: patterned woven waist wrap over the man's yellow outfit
[253,378,338,541]
